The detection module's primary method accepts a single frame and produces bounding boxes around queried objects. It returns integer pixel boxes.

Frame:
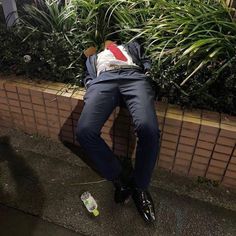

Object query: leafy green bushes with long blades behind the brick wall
[0,0,236,114]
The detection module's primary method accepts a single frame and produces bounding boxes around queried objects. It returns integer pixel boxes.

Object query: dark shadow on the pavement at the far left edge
[0,136,45,236]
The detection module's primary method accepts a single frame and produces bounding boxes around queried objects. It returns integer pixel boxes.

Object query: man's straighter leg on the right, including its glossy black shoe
[119,80,159,223]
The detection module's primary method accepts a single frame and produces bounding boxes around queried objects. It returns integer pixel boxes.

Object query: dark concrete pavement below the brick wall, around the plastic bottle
[0,130,236,236]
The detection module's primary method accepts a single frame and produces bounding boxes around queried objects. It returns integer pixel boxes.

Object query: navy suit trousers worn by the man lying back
[76,79,160,189]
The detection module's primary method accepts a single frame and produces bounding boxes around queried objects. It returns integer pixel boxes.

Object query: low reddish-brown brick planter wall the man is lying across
[0,76,236,187]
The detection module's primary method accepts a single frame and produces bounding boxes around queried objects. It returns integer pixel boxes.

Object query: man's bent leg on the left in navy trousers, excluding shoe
[76,81,121,180]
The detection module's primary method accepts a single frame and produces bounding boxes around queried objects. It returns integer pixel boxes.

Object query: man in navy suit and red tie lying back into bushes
[76,40,159,222]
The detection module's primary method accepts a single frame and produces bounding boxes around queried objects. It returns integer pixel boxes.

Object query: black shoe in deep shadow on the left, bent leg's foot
[113,179,132,203]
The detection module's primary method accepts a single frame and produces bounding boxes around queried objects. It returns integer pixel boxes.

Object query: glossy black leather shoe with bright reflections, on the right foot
[132,188,156,223]
